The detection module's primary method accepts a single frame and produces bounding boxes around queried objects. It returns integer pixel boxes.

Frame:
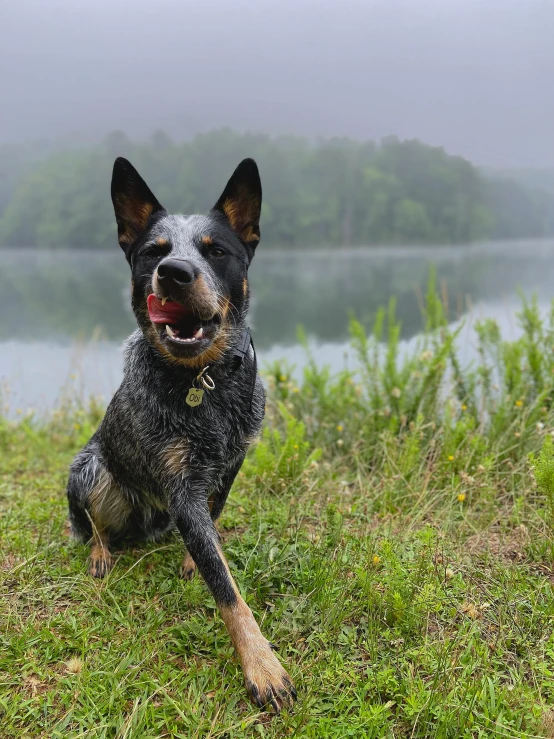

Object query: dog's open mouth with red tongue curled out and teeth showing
[147,293,219,349]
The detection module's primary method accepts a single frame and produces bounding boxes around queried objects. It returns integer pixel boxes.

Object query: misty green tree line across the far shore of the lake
[0,130,554,249]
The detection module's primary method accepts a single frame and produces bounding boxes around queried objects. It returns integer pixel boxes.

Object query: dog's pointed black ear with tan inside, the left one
[112,157,165,261]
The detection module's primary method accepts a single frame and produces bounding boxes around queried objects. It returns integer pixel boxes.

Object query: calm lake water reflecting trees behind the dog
[0,240,554,416]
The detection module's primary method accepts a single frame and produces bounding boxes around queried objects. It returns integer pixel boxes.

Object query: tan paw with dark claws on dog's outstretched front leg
[244,647,296,713]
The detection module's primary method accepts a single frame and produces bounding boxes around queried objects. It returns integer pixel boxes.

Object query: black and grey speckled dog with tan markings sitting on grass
[67,159,296,710]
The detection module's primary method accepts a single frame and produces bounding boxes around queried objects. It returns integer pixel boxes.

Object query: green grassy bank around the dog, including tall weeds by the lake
[0,278,554,739]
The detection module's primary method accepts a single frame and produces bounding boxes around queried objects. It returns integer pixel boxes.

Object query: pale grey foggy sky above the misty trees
[0,0,554,168]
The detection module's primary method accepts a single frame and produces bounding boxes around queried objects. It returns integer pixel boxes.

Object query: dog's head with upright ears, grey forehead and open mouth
[112,158,262,368]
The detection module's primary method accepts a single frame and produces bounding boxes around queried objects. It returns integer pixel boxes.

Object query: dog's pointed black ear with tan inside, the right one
[212,159,262,249]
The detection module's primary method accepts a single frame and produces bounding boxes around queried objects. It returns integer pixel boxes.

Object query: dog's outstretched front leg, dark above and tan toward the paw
[171,482,296,711]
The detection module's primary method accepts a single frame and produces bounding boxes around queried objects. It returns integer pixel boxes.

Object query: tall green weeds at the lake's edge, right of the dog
[258,279,554,528]
